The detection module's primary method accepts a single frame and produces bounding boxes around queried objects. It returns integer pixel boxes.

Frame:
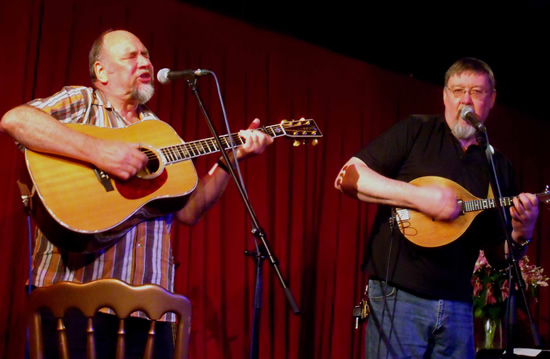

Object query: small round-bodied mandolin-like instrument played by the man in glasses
[394,176,550,247]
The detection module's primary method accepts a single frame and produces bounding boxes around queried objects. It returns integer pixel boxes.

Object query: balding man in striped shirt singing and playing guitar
[0,30,273,358]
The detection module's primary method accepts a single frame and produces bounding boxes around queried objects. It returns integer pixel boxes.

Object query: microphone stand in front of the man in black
[476,126,541,359]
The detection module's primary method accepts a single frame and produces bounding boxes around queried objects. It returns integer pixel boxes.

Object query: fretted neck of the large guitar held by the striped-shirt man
[160,124,286,164]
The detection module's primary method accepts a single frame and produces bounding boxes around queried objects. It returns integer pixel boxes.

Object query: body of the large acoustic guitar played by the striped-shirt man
[25,120,198,252]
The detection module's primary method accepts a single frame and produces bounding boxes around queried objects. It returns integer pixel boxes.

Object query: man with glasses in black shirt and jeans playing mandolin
[335,58,538,358]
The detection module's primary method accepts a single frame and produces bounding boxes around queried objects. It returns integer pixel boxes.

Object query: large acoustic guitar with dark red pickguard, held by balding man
[25,119,322,252]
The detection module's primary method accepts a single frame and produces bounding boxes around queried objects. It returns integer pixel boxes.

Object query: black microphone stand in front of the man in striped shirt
[187,77,300,359]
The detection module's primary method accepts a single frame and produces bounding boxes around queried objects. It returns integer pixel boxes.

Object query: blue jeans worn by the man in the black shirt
[366,279,475,359]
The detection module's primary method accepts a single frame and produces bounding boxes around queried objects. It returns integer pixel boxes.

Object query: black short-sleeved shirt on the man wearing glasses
[355,116,516,301]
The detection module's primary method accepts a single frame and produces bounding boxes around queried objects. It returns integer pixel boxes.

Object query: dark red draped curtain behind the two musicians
[0,0,550,359]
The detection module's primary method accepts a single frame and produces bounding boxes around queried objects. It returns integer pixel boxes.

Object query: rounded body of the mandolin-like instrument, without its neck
[396,176,486,247]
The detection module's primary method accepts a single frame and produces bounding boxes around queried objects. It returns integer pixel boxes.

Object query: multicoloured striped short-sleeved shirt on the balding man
[28,86,174,320]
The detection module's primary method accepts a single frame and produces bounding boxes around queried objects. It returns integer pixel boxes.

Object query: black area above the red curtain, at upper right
[185,0,550,119]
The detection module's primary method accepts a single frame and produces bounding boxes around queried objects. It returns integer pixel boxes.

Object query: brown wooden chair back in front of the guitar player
[27,279,191,359]
